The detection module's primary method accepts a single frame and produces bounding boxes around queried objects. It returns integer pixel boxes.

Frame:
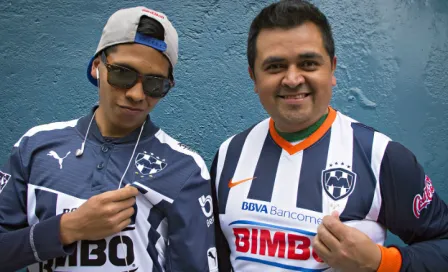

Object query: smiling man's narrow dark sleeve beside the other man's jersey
[210,154,232,272]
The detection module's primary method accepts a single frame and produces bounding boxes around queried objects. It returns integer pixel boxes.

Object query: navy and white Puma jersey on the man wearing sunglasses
[0,107,217,272]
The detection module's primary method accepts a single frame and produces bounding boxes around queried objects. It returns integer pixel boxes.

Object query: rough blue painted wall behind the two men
[0,0,448,264]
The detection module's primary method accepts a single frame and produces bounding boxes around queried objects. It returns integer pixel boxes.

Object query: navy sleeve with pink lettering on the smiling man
[378,142,448,271]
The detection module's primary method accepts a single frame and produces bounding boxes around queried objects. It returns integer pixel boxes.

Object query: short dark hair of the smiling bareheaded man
[247,0,335,71]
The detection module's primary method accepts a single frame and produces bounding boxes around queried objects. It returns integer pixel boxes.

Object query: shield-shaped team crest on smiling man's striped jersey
[322,163,356,200]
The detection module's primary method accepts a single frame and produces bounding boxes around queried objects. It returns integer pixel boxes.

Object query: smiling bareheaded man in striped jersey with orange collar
[211,0,448,272]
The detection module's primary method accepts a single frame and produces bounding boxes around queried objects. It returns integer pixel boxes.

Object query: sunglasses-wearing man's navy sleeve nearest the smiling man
[166,164,218,272]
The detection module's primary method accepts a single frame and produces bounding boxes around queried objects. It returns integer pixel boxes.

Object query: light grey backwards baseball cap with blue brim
[87,6,179,86]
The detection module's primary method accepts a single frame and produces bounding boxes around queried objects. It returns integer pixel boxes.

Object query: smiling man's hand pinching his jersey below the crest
[312,212,381,271]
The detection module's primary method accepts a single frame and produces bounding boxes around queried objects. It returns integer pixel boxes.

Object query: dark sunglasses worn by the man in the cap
[101,51,174,98]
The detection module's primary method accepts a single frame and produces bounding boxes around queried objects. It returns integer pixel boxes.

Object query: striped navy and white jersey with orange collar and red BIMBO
[211,108,448,272]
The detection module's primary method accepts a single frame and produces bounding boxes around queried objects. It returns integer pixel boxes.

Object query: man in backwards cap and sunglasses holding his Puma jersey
[0,7,217,272]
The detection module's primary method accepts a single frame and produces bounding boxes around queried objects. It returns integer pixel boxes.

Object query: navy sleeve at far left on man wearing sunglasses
[0,139,70,271]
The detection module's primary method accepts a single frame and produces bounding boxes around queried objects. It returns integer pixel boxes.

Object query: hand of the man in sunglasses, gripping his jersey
[60,186,139,245]
